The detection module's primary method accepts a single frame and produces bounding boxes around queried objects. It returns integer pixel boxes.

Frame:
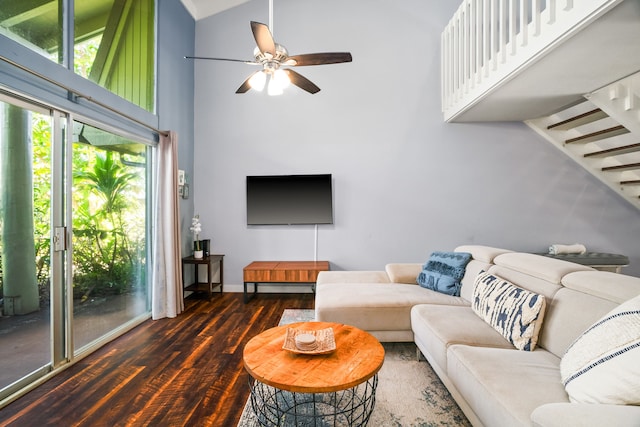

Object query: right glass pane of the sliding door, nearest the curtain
[72,122,148,350]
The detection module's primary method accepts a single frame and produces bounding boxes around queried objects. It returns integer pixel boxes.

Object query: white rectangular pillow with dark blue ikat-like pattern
[471,271,546,351]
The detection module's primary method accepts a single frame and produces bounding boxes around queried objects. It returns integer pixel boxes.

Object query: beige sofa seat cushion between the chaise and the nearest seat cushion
[411,304,513,372]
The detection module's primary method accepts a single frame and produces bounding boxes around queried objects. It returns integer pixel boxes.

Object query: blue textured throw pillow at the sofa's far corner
[417,252,471,296]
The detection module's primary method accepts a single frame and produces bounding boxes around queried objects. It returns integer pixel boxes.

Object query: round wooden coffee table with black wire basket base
[243,322,384,426]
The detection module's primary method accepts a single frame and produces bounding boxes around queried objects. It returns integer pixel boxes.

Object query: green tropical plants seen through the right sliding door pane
[73,146,144,302]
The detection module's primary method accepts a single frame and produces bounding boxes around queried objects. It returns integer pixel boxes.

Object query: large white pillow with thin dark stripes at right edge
[560,295,640,405]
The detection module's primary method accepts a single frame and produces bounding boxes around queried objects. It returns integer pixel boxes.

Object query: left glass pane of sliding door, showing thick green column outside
[0,98,53,389]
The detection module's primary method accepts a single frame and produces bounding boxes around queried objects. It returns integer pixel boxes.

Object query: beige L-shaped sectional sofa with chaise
[315,245,640,427]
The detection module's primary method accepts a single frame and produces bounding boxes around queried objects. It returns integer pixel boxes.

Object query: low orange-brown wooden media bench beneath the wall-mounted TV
[243,261,329,304]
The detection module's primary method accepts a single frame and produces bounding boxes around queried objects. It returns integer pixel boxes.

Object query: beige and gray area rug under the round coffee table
[238,309,471,427]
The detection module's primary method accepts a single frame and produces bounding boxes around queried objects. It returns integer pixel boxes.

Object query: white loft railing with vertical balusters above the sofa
[441,0,623,121]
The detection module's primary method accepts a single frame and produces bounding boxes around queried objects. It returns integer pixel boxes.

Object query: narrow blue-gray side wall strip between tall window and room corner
[158,0,195,253]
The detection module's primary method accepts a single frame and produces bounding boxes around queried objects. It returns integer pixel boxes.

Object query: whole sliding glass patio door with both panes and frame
[0,93,152,401]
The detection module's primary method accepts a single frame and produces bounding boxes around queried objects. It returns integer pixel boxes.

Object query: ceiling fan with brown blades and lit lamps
[185,0,352,95]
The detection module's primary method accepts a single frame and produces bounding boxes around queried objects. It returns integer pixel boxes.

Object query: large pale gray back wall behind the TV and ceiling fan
[193,0,640,285]
